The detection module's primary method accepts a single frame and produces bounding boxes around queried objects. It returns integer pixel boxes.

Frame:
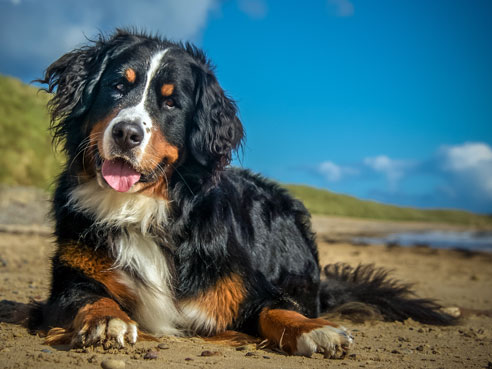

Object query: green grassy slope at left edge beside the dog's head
[0,75,62,189]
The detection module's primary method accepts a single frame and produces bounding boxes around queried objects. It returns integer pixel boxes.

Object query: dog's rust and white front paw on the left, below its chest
[71,298,138,347]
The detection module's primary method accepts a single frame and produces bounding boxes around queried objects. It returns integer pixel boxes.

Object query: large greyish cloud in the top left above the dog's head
[0,0,219,74]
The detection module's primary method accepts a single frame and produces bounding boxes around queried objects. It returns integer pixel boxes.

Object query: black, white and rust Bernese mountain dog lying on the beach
[29,30,452,358]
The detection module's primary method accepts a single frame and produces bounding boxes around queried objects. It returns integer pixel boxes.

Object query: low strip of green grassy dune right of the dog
[284,185,492,227]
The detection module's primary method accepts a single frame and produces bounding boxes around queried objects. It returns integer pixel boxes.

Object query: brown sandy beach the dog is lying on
[0,197,492,369]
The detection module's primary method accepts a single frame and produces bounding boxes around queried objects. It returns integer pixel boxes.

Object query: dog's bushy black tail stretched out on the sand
[320,263,456,325]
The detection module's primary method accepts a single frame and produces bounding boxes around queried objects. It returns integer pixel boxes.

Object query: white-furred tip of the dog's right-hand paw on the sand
[294,325,354,359]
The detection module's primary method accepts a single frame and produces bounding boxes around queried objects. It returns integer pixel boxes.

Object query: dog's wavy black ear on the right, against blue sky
[190,64,244,171]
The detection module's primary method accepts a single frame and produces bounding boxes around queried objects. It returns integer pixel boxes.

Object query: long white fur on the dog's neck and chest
[70,181,186,335]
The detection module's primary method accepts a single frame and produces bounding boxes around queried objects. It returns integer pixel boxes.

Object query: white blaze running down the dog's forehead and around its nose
[102,49,168,159]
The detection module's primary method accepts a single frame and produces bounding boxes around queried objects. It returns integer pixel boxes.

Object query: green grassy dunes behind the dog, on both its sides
[0,75,492,226]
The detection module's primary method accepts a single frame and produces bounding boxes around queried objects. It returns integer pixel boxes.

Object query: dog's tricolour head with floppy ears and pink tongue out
[40,31,243,192]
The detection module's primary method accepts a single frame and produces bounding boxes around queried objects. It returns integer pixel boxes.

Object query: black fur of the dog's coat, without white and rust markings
[30,27,451,340]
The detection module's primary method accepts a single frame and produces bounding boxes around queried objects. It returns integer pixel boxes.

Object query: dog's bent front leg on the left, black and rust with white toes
[36,244,138,347]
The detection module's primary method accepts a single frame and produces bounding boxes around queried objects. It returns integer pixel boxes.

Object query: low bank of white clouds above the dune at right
[309,142,492,214]
